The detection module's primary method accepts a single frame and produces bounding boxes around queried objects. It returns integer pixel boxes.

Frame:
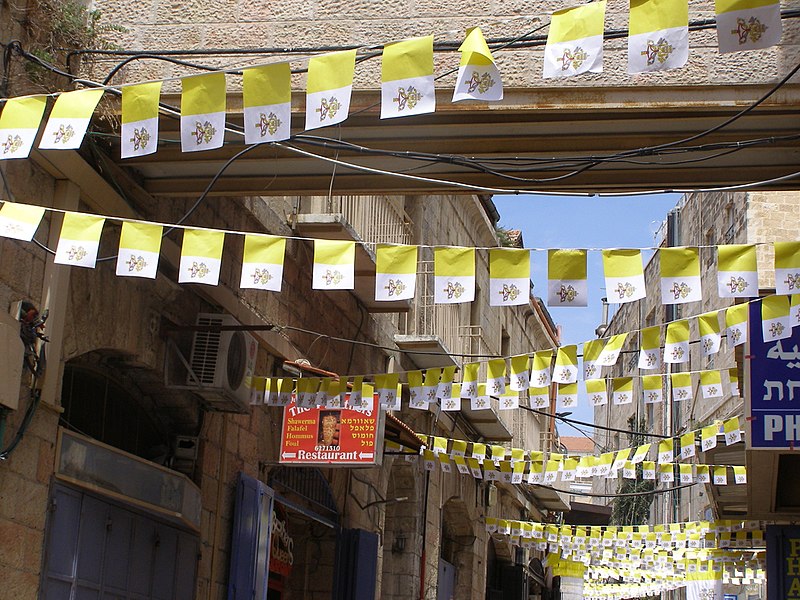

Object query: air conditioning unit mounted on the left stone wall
[186,313,258,413]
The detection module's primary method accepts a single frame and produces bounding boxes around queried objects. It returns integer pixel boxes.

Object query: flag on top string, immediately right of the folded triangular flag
[543,0,606,79]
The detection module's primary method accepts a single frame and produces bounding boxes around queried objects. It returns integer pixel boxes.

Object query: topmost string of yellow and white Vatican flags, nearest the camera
[0,0,781,160]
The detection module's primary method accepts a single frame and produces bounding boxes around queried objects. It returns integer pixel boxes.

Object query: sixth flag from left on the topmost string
[306,50,356,129]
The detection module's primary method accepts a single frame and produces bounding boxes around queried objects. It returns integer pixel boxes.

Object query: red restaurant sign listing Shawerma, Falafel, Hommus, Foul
[280,397,385,466]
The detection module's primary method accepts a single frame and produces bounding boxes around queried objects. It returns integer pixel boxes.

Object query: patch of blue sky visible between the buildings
[493,194,680,424]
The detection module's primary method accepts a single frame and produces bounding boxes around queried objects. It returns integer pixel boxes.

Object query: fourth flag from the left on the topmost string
[181,73,225,152]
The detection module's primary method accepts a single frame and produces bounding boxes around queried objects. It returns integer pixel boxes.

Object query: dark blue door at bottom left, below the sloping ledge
[41,484,199,600]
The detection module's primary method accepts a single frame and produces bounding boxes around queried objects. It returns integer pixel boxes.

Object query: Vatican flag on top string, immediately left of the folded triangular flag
[381,35,436,119]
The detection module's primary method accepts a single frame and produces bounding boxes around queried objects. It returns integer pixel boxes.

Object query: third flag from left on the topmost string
[120,81,162,158]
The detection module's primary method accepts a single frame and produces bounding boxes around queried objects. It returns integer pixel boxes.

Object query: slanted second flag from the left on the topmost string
[39,89,103,150]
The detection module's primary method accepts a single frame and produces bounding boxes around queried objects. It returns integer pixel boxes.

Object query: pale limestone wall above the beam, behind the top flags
[90,0,798,92]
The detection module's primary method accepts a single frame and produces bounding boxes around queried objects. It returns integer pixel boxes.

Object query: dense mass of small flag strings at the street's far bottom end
[486,517,766,600]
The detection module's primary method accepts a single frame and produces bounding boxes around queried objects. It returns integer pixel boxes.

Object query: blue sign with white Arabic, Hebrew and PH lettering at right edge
[746,302,800,448]
